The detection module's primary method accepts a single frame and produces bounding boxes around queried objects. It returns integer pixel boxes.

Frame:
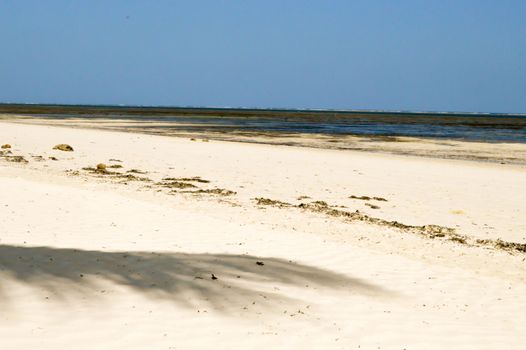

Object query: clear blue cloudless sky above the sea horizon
[0,0,526,113]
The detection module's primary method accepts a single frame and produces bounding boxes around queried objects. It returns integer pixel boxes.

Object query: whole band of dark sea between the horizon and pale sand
[0,104,526,143]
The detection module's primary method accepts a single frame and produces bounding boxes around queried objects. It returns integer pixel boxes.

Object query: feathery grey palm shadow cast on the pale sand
[0,245,392,309]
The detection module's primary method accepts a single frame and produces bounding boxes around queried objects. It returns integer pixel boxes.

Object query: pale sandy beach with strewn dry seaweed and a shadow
[0,121,526,349]
